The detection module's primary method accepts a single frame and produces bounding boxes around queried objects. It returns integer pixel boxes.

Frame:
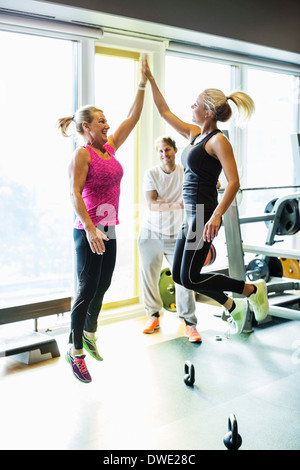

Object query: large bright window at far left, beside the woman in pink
[0,32,75,307]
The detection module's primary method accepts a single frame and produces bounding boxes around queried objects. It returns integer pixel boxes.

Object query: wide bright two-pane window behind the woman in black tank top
[165,54,299,267]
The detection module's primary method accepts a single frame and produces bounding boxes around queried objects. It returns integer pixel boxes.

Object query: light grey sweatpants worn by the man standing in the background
[138,229,197,325]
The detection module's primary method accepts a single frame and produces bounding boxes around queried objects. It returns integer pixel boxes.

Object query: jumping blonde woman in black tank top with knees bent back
[143,60,268,333]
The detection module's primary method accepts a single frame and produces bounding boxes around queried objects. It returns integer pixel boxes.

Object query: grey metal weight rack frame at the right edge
[223,188,300,333]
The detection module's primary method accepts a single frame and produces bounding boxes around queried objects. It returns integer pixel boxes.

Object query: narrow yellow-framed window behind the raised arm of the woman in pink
[95,47,139,305]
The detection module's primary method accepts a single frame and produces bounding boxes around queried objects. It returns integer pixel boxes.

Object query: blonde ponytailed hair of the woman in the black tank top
[201,88,255,126]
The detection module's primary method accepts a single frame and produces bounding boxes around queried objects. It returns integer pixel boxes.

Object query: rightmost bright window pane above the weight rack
[240,67,299,252]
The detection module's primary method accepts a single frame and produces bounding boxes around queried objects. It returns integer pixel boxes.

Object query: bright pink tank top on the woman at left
[74,144,123,230]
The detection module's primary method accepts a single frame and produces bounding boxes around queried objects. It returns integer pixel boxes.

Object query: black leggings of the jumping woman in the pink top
[69,226,117,349]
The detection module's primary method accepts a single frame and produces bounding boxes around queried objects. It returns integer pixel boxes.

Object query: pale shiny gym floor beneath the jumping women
[0,302,300,450]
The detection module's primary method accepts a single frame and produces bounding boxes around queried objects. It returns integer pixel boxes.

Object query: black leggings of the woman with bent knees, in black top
[173,211,245,305]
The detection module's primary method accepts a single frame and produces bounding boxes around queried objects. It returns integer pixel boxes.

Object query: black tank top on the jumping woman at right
[181,129,222,211]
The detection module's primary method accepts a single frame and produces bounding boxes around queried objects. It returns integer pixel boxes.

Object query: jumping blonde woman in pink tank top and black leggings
[58,59,147,383]
